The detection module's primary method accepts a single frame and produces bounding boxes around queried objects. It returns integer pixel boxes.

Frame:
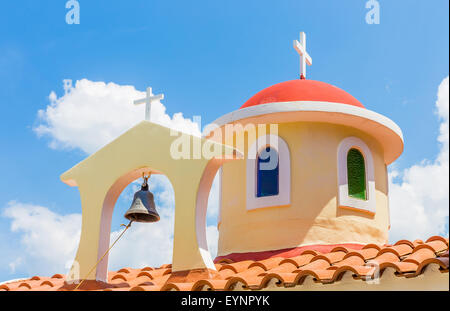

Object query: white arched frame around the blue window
[246,134,291,210]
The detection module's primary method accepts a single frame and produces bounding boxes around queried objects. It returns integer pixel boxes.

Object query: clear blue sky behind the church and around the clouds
[0,0,449,281]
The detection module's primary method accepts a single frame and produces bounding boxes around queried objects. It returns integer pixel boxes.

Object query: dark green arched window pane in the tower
[347,148,367,200]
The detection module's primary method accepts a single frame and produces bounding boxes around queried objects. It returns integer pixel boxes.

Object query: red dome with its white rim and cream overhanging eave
[209,79,403,164]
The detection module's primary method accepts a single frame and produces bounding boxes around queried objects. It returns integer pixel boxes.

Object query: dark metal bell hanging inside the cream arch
[124,175,160,222]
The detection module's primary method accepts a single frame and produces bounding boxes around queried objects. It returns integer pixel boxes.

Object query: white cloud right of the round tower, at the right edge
[389,77,449,242]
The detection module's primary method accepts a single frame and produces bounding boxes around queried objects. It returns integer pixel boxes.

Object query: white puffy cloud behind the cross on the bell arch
[34,79,200,153]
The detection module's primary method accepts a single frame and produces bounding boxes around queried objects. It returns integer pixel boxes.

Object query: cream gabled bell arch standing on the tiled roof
[61,121,241,282]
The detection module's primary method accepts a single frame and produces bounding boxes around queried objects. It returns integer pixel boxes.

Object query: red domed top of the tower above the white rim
[241,79,365,109]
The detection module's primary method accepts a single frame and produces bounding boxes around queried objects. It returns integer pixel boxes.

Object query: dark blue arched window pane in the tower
[256,146,279,197]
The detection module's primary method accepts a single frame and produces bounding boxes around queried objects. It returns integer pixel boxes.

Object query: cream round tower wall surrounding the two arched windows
[218,122,389,256]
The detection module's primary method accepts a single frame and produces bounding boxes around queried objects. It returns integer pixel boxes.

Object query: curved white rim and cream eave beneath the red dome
[206,101,403,164]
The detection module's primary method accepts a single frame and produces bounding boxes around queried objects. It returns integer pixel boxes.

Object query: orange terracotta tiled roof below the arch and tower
[0,236,449,291]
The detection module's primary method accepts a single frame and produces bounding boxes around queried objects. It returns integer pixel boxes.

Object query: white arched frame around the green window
[337,136,376,214]
